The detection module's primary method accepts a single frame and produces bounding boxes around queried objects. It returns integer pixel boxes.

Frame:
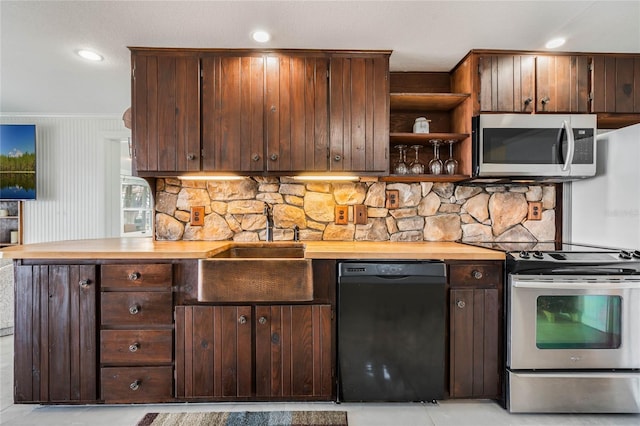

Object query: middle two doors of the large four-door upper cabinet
[202,54,329,172]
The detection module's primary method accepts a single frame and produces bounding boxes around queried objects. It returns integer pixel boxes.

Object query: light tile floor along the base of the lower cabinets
[0,336,640,426]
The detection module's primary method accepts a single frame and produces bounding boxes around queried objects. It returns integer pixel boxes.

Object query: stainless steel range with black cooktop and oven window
[506,244,640,413]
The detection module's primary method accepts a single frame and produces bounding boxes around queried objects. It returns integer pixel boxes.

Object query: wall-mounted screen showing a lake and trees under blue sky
[0,124,36,200]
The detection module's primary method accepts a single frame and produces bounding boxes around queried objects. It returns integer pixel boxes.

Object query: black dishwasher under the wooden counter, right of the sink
[338,261,446,402]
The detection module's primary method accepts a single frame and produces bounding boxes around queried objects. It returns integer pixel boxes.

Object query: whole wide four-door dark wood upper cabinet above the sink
[131,48,391,176]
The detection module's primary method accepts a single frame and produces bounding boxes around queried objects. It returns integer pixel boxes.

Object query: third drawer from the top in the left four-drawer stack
[100,330,173,364]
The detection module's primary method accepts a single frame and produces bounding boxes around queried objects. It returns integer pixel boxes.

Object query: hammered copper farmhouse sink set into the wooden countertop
[198,243,313,303]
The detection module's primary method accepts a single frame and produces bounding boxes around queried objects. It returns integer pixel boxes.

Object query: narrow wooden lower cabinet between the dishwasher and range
[449,262,503,399]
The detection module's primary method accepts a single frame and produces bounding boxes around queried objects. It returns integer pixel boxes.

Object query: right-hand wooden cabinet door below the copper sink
[255,305,333,399]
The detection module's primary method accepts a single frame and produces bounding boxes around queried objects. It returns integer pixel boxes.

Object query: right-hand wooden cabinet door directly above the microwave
[536,55,590,113]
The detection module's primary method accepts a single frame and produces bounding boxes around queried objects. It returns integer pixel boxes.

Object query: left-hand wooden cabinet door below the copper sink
[175,306,253,399]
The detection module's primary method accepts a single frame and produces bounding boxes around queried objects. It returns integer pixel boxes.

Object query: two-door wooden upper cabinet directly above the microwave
[478,54,589,113]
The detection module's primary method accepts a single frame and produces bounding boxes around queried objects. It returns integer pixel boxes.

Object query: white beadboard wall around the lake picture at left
[0,115,129,244]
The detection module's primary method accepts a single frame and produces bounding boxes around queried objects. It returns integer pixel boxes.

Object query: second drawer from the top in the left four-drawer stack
[100,291,173,326]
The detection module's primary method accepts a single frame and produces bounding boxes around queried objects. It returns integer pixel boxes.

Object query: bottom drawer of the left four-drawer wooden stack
[100,367,173,403]
